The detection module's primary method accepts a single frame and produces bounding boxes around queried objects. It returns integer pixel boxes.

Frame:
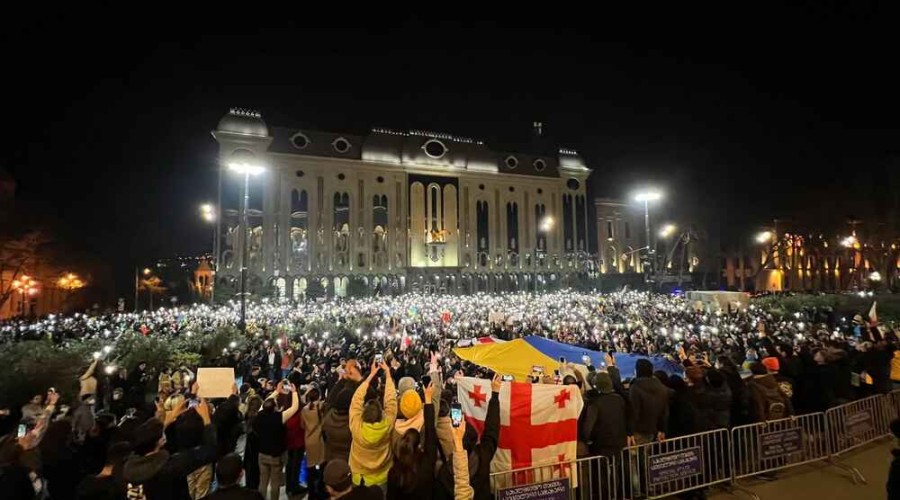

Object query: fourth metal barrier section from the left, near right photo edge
[825,396,890,455]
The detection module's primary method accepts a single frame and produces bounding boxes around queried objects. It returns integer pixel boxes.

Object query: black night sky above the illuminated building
[0,2,900,293]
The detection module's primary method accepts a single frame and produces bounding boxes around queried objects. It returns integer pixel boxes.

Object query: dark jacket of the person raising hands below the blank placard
[122,425,216,500]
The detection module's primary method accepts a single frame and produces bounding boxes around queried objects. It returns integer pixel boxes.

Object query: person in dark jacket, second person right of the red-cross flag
[629,359,669,444]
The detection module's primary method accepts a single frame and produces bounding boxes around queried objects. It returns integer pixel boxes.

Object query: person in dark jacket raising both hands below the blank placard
[122,399,216,500]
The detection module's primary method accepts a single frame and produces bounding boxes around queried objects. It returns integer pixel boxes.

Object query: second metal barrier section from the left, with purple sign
[615,429,731,500]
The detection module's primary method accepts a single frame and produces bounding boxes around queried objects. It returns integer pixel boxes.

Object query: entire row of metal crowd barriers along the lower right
[491,390,900,500]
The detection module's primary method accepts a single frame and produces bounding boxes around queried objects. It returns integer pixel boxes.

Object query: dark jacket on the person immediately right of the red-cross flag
[578,390,631,457]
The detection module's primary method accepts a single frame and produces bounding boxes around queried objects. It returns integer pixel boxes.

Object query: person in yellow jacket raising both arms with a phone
[349,362,397,488]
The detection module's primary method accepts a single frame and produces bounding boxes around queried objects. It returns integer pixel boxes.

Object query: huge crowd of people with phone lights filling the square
[0,291,900,500]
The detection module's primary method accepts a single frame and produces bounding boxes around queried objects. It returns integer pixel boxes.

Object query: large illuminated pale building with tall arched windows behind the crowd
[213,110,591,299]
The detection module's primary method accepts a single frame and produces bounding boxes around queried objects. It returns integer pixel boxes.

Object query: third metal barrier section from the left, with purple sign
[731,413,831,481]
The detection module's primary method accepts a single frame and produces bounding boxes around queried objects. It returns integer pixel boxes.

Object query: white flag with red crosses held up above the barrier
[456,377,584,484]
